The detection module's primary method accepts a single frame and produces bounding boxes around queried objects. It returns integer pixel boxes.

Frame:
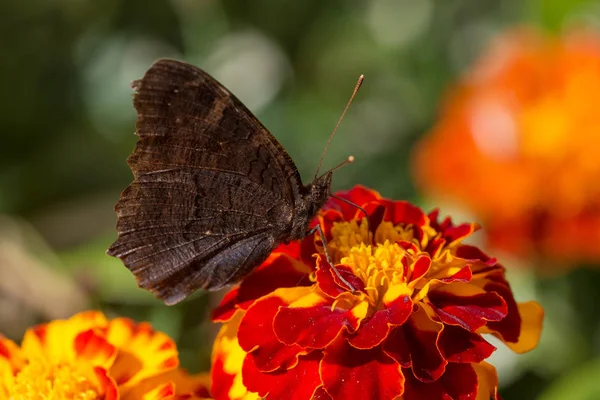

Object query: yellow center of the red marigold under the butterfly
[327,219,416,306]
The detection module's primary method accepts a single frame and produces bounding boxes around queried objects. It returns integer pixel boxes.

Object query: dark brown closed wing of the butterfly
[108,60,302,304]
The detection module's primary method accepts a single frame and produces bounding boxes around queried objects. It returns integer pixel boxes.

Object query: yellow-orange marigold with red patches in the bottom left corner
[0,311,208,400]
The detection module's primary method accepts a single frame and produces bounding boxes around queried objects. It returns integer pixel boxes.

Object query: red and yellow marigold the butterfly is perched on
[211,187,543,400]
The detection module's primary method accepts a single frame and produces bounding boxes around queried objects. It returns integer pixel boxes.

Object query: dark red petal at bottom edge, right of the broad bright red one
[403,364,477,400]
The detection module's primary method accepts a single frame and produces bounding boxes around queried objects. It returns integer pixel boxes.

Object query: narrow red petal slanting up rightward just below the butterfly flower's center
[348,296,413,349]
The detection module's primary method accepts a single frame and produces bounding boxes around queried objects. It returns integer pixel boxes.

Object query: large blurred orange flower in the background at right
[414,30,600,262]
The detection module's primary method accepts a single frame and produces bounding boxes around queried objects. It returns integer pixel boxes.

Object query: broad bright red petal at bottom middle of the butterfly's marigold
[321,340,404,400]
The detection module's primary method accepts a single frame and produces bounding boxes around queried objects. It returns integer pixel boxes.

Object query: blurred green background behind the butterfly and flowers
[0,0,600,400]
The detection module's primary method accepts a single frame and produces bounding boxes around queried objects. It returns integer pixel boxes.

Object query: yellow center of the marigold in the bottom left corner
[9,360,102,400]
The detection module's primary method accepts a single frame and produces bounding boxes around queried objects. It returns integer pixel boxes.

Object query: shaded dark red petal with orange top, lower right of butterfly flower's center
[383,307,448,382]
